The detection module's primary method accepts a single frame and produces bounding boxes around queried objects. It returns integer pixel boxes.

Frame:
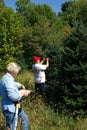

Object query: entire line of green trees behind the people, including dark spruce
[0,0,87,116]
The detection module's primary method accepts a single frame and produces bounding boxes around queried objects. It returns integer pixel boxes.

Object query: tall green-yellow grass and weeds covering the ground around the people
[0,72,87,130]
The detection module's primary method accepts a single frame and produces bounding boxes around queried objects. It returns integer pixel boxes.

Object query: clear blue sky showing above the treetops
[5,0,69,13]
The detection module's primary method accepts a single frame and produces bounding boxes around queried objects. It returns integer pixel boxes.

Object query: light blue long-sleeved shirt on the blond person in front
[0,73,21,113]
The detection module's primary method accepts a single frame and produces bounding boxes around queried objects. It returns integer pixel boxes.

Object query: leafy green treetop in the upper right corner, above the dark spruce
[59,0,87,27]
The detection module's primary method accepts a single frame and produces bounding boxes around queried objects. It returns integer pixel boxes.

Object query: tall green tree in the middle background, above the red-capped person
[16,4,62,69]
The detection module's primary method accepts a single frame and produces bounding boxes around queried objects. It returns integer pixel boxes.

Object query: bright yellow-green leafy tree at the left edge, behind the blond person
[0,8,23,70]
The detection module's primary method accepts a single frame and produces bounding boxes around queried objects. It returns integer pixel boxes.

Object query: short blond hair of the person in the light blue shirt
[7,62,21,74]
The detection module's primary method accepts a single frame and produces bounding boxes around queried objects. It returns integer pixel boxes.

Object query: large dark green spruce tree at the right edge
[61,23,87,115]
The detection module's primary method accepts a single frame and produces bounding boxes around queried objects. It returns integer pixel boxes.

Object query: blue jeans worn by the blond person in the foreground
[3,110,29,130]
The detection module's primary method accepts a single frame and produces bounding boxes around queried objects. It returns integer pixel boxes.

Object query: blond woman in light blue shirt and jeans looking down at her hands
[0,62,31,130]
